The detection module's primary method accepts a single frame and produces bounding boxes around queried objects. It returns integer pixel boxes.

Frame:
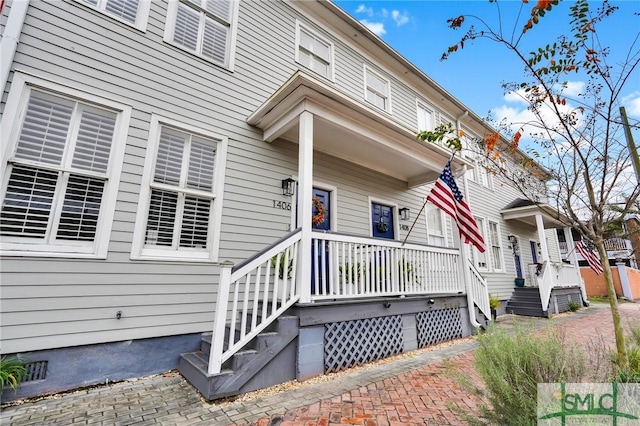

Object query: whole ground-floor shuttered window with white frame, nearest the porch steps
[134,117,226,260]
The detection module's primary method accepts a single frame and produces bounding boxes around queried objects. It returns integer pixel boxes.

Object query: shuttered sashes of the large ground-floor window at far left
[0,90,118,250]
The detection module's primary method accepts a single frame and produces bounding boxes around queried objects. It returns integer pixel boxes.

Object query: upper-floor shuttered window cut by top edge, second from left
[164,0,236,68]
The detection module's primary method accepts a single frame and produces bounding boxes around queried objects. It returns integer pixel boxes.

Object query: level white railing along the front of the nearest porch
[311,232,465,300]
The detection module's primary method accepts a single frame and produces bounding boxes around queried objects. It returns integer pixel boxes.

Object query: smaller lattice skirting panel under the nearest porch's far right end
[416,308,462,348]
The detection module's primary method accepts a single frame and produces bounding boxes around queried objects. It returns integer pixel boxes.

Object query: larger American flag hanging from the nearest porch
[427,161,485,253]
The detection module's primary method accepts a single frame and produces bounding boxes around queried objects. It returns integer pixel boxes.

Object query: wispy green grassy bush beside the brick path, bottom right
[459,327,586,426]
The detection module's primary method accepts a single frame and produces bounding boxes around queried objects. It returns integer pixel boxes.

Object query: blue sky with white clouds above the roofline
[334,0,640,125]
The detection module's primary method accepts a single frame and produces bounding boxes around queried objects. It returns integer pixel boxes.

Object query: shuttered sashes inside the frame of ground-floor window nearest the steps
[143,126,218,253]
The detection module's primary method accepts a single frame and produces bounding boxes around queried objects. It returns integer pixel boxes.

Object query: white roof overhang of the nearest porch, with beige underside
[247,71,472,188]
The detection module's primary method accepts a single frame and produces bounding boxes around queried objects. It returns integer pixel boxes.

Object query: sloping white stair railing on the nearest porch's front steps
[209,229,301,374]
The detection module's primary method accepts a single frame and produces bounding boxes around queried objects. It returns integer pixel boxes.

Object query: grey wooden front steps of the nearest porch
[178,316,299,400]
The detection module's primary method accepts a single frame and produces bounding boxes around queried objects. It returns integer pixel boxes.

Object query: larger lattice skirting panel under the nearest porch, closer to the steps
[324,315,404,373]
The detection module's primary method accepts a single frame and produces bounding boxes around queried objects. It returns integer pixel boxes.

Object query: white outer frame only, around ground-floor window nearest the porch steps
[131,114,228,262]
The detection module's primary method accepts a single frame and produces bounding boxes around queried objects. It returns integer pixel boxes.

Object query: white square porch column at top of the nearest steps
[296,111,313,303]
